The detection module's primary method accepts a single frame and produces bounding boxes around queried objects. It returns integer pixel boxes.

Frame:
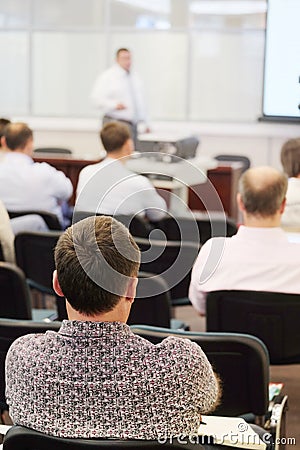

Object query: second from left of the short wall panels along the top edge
[33,0,106,29]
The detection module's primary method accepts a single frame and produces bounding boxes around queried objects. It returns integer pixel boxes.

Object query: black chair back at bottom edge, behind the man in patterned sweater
[3,425,209,450]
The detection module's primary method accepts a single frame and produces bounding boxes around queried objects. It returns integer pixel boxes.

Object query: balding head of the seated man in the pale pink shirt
[239,166,287,217]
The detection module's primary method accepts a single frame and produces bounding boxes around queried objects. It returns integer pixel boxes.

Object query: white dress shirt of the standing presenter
[91,64,147,123]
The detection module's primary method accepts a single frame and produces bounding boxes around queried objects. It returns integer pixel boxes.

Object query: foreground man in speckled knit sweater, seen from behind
[6,216,219,439]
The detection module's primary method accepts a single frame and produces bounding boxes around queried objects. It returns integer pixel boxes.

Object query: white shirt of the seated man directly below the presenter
[75,157,167,221]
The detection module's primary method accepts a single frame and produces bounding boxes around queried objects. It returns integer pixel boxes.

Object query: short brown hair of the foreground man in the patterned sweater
[55,216,140,316]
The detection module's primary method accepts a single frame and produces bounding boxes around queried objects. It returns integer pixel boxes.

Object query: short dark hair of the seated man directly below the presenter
[100,121,131,153]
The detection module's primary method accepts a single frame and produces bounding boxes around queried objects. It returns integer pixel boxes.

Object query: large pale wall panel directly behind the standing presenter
[110,32,188,120]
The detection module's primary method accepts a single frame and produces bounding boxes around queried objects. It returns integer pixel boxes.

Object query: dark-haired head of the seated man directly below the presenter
[100,121,134,162]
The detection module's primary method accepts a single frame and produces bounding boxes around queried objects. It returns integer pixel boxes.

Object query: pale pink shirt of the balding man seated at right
[189,226,300,314]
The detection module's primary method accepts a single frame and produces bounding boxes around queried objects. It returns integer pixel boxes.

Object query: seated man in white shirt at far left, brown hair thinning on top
[0,123,73,224]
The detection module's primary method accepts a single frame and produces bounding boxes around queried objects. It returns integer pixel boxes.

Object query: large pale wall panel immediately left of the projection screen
[190,31,264,121]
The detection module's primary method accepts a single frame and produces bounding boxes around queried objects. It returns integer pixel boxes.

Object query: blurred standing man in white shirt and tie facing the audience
[91,48,148,143]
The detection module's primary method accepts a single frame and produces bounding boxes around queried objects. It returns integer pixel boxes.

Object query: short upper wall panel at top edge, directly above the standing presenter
[110,0,189,29]
